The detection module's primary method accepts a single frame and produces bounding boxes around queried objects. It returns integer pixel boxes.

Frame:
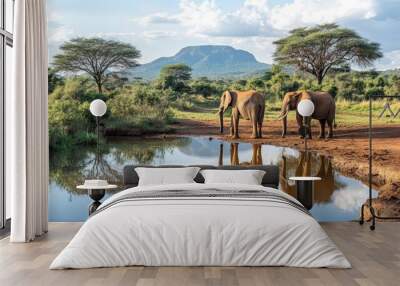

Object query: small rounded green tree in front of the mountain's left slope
[160,64,192,91]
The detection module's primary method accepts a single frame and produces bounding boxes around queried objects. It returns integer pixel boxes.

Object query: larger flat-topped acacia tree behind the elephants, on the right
[274,24,383,84]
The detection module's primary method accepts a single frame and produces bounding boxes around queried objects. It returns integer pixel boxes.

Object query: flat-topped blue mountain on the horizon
[129,45,271,79]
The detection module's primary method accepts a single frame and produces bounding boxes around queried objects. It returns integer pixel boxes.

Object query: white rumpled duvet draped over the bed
[50,184,350,269]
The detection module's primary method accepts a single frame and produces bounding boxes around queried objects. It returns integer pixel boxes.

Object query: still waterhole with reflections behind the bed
[49,137,377,221]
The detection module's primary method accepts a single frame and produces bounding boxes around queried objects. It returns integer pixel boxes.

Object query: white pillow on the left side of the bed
[135,167,200,186]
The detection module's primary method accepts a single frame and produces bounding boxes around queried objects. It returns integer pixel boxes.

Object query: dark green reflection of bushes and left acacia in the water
[50,138,190,194]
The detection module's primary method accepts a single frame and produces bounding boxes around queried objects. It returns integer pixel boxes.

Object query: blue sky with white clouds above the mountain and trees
[48,0,400,69]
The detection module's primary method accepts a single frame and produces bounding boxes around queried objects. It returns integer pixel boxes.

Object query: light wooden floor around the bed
[0,222,400,286]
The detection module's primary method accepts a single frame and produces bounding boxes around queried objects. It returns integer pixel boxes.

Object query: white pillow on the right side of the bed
[200,170,265,185]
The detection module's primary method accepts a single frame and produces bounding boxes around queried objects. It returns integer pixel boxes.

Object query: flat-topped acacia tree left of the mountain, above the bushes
[53,38,140,93]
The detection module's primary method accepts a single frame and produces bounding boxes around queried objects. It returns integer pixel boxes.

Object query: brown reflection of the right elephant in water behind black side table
[279,152,338,203]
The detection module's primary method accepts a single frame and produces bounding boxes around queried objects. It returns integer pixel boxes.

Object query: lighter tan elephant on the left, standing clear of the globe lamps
[218,90,265,139]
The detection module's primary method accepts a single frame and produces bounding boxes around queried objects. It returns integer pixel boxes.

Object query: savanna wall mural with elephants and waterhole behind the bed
[48,0,400,221]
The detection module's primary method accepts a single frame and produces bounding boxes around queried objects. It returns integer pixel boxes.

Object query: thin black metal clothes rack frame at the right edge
[360,95,400,230]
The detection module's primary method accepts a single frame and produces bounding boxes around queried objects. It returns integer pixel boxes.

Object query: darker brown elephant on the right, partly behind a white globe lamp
[279,91,336,139]
